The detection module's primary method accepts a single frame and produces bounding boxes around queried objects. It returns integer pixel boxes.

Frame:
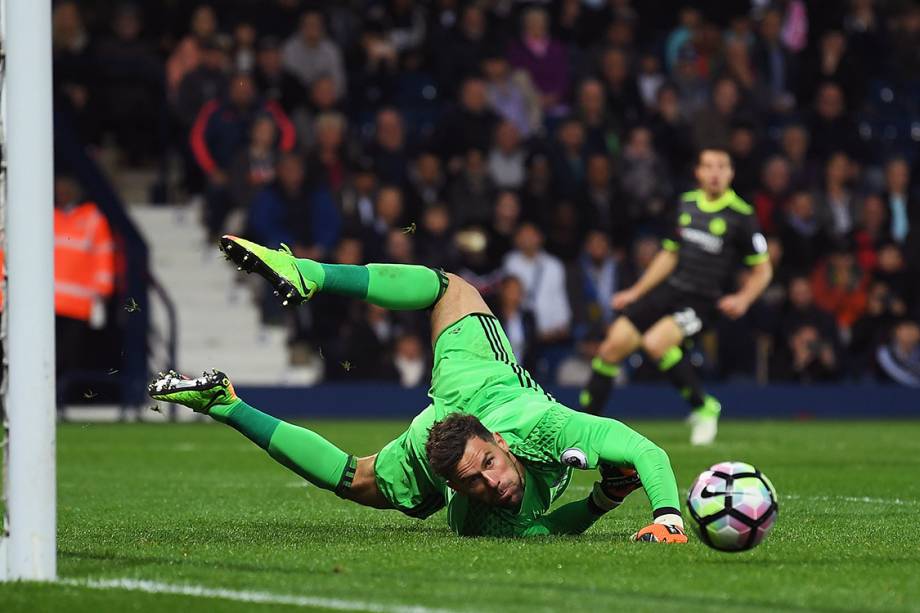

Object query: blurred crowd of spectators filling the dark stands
[54,0,920,385]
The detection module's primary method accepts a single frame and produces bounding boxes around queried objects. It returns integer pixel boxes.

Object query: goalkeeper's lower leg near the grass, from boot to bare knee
[148,371,392,509]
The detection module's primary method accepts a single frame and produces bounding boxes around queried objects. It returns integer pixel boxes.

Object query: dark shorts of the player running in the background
[623,282,716,338]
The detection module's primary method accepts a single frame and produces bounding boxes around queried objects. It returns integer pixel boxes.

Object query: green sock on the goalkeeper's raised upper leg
[296,258,447,311]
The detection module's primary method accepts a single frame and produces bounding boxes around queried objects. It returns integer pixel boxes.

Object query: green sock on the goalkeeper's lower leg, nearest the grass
[209,399,357,496]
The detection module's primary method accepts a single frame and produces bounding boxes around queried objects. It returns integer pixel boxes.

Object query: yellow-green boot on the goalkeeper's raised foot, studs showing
[220,234,322,306]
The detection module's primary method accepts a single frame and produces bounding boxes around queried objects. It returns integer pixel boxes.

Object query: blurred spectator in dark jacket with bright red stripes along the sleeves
[190,73,294,237]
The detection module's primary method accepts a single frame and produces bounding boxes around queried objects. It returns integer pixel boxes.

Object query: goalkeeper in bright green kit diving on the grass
[149,236,687,543]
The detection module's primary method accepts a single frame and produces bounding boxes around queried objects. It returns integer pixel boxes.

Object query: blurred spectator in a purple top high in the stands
[508,7,569,117]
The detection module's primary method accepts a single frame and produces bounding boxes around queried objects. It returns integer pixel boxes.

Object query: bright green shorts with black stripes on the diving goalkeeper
[374,314,559,519]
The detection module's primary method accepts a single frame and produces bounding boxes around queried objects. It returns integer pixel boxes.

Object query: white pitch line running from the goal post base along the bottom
[58,579,457,613]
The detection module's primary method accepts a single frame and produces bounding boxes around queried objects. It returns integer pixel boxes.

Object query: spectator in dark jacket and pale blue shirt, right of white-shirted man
[566,230,623,344]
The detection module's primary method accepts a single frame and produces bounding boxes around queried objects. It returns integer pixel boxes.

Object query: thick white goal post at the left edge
[0,0,57,581]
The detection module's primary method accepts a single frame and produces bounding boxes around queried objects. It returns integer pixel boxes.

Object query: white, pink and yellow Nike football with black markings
[687,462,779,551]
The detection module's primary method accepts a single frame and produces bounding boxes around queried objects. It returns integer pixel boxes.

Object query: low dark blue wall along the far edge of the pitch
[237,383,920,419]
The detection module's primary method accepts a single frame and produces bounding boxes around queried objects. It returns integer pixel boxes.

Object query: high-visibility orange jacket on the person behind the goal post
[0,202,115,321]
